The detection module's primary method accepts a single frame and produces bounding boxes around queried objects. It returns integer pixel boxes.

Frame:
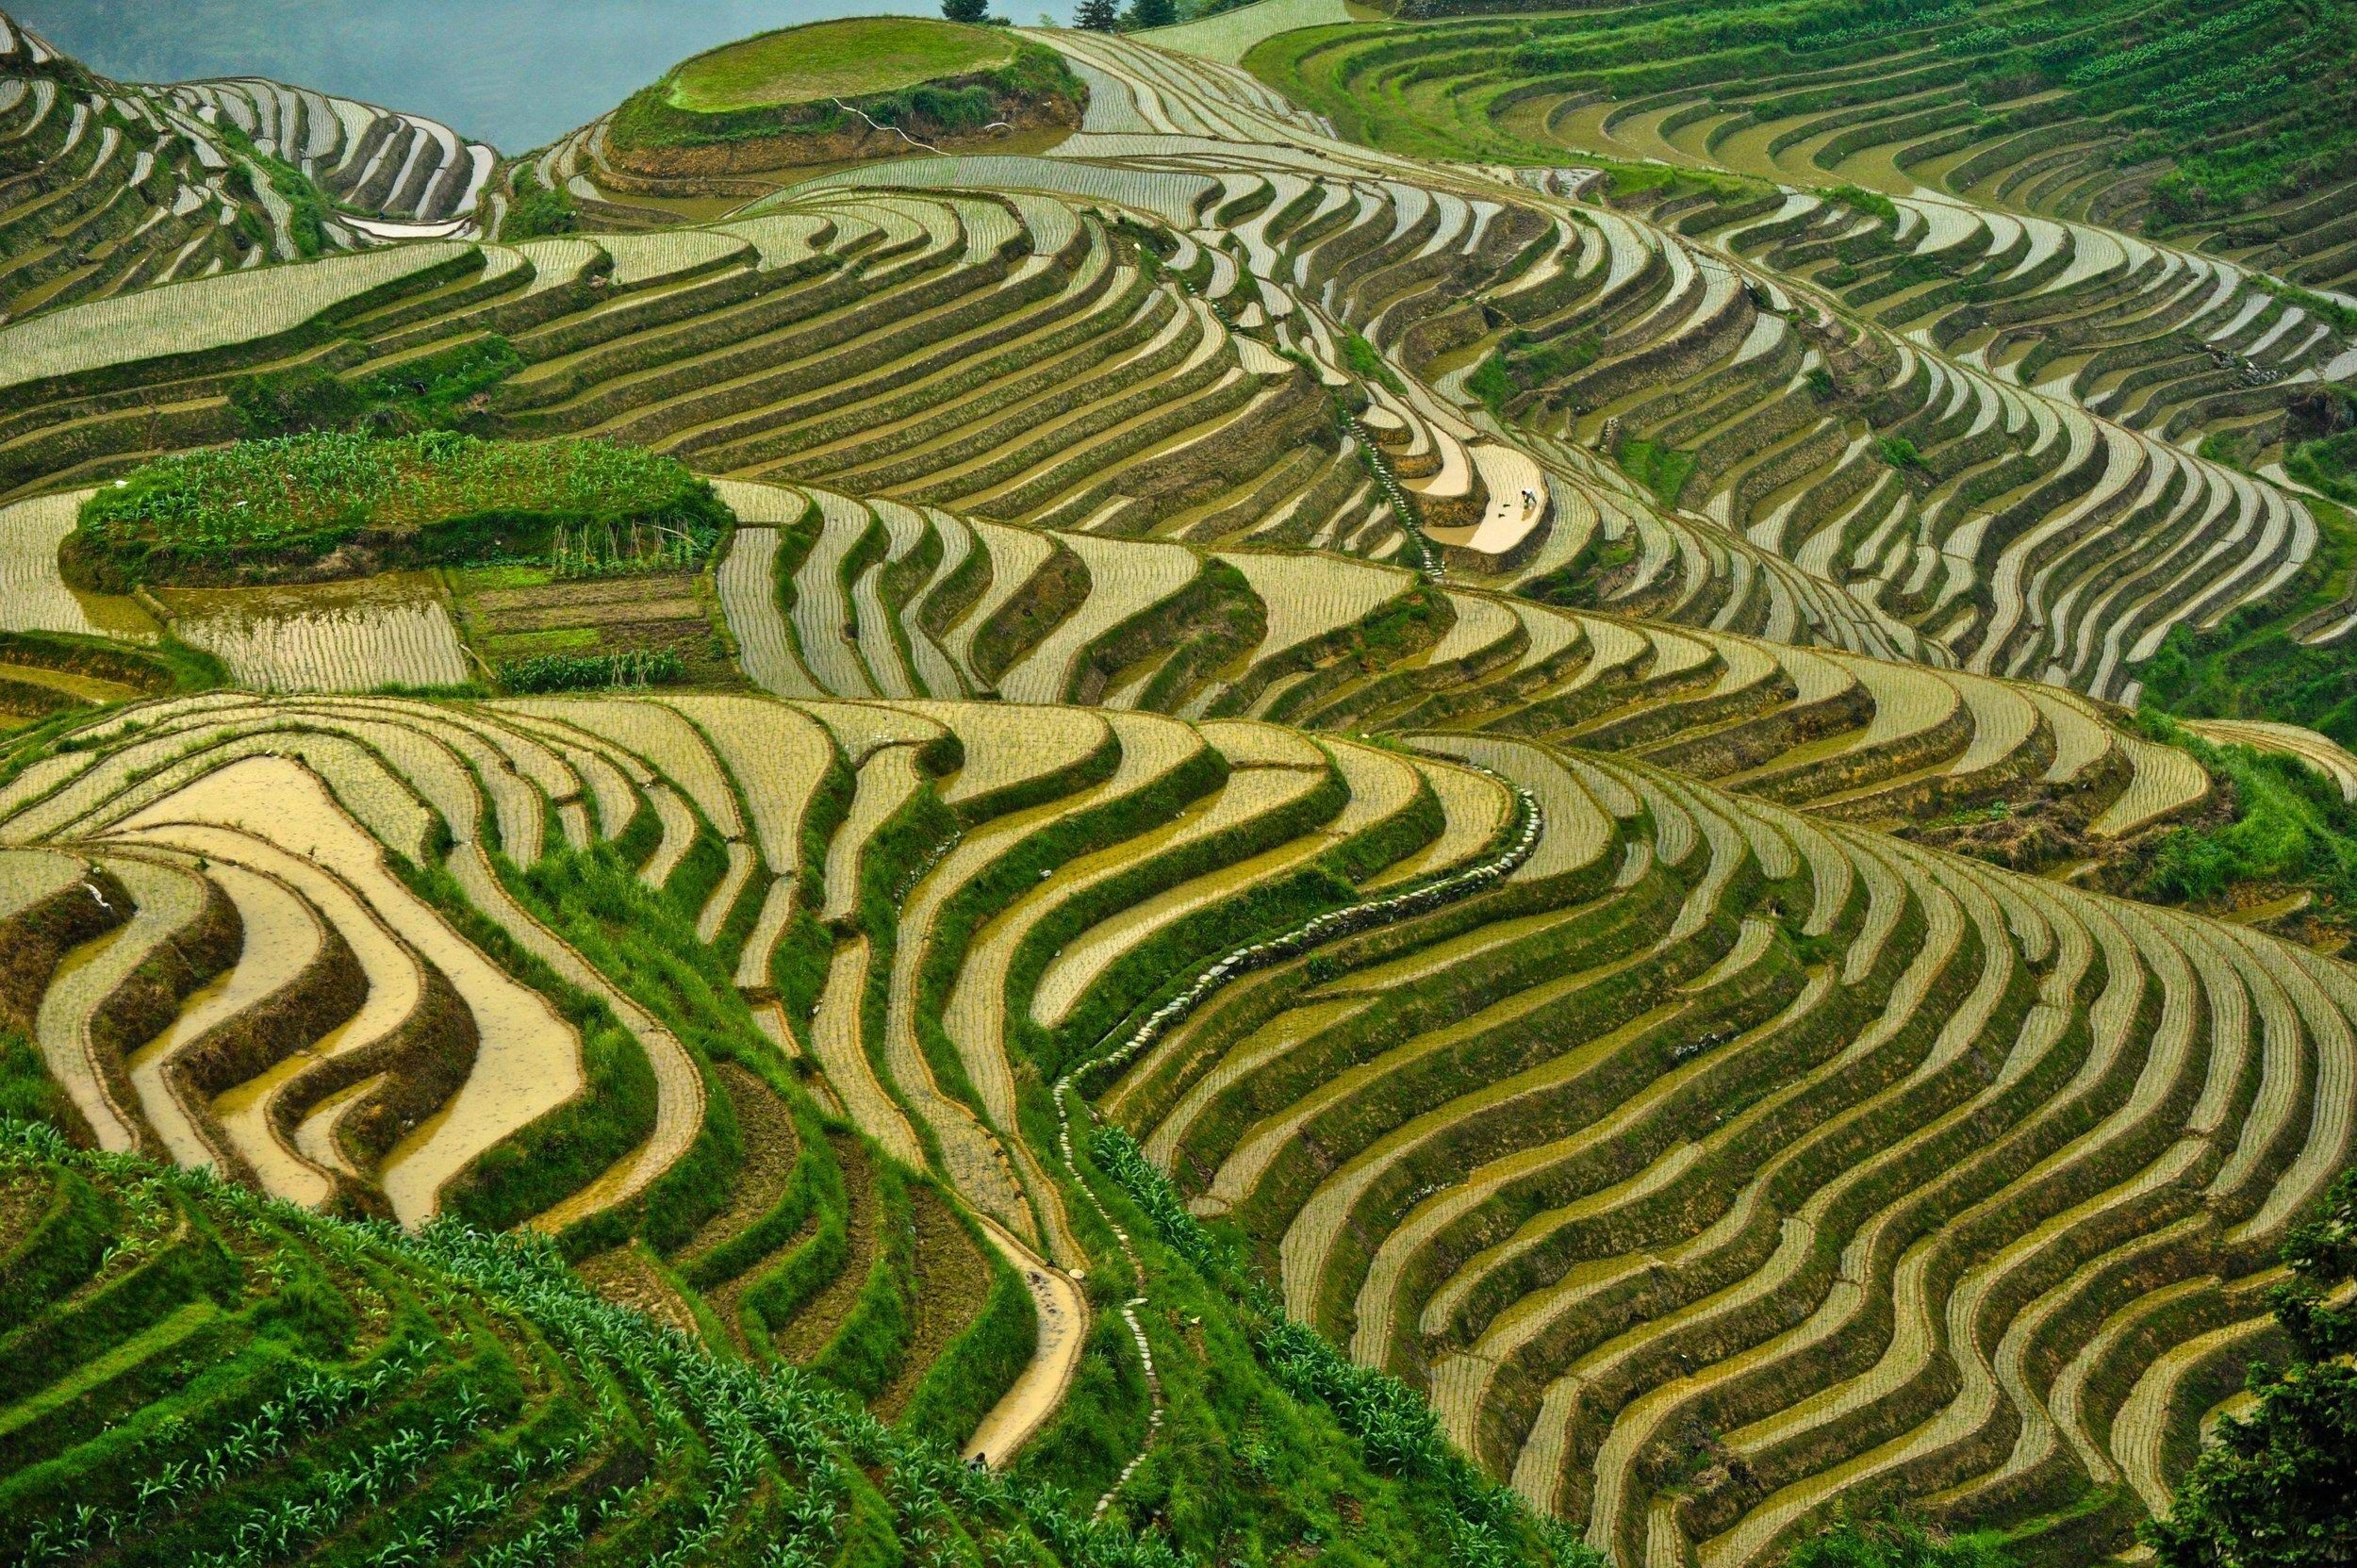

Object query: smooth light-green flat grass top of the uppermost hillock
[665,17,1018,113]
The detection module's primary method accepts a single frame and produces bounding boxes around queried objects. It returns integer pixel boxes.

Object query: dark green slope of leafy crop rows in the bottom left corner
[0,1120,1216,1568]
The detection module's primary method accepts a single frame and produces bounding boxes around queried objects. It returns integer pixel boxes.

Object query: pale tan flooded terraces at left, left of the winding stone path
[0,696,1502,1427]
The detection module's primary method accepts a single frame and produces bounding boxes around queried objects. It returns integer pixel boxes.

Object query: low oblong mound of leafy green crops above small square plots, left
[64,432,733,592]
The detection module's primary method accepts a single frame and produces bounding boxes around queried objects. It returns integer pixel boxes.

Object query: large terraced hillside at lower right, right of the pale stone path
[1103,738,2357,1560]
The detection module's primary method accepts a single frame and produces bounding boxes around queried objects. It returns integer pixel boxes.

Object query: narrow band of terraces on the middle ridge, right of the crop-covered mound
[698,486,2209,839]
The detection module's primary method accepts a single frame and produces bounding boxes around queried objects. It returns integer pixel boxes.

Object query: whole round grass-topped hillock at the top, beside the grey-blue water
[606,17,1087,177]
